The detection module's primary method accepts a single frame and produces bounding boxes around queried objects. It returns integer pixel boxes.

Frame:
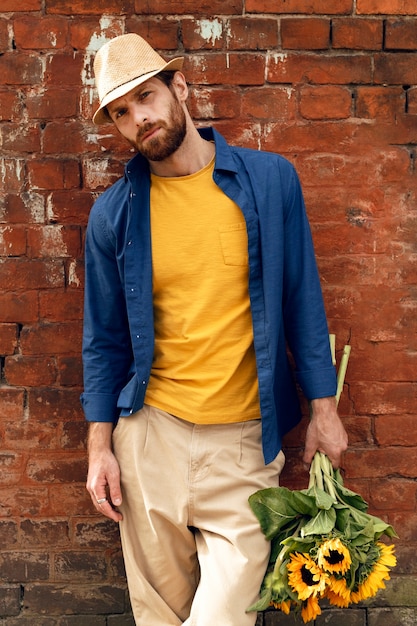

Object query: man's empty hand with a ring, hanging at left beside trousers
[86,422,123,522]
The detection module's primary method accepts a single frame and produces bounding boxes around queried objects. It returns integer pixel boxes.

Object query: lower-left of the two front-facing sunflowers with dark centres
[287,552,328,600]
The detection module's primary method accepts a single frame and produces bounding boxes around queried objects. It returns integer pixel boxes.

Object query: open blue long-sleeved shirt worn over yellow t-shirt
[81,129,337,463]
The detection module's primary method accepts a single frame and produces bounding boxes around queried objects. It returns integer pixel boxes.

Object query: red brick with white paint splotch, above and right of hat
[181,18,227,50]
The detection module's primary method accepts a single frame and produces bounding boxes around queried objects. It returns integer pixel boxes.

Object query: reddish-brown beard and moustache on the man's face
[132,96,187,161]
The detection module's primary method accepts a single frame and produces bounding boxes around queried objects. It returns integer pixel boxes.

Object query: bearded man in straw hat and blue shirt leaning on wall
[82,34,347,626]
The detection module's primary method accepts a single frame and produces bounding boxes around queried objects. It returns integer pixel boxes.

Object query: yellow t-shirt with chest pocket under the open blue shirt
[145,159,260,424]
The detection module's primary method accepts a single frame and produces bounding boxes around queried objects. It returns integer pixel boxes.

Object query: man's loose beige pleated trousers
[113,405,284,626]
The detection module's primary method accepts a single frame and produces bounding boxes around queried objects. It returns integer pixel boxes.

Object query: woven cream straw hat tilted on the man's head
[93,33,184,124]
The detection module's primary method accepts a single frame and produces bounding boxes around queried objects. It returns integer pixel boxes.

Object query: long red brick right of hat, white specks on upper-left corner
[267,53,372,85]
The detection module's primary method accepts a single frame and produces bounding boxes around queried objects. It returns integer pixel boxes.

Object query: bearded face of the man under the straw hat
[107,78,187,161]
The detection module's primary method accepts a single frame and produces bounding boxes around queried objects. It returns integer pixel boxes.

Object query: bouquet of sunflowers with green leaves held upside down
[248,338,397,623]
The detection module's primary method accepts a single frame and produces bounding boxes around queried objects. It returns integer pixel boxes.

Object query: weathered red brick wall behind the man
[0,0,417,626]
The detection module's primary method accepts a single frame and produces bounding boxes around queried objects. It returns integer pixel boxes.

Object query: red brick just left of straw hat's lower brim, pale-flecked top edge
[26,87,79,121]
